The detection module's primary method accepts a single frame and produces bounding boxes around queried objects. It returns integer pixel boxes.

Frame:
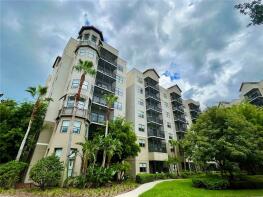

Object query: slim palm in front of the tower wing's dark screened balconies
[101,94,118,167]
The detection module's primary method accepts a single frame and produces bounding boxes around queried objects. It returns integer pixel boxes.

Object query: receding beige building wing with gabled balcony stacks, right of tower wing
[126,68,200,175]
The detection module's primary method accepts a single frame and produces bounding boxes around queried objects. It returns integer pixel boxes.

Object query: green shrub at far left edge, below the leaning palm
[0,161,27,189]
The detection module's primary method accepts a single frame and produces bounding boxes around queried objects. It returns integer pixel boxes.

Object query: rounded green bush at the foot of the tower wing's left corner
[29,155,64,190]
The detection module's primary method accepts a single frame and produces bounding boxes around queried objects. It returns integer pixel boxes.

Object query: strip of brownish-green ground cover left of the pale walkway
[0,181,138,197]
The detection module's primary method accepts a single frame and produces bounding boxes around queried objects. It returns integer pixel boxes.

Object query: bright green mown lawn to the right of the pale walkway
[140,179,263,197]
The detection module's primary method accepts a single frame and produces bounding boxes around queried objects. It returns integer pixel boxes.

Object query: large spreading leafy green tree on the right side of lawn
[183,103,263,178]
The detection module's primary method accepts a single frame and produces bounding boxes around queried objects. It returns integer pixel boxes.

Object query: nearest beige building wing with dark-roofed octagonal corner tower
[25,26,126,182]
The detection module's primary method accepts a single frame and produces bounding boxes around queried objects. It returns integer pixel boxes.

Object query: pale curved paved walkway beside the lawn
[116,179,174,197]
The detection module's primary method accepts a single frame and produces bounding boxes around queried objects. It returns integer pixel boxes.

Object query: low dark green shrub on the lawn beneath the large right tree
[192,176,229,190]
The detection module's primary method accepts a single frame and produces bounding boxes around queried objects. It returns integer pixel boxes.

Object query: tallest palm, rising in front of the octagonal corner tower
[66,59,96,177]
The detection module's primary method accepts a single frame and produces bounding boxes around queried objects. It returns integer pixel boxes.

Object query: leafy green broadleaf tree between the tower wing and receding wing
[109,117,140,161]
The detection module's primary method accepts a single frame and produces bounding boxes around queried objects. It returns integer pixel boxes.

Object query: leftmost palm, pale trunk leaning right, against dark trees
[16,85,52,161]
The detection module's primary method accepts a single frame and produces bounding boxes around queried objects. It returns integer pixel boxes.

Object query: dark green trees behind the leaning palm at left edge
[0,100,46,163]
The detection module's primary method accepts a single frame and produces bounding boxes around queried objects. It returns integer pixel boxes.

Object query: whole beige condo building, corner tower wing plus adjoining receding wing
[25,26,200,182]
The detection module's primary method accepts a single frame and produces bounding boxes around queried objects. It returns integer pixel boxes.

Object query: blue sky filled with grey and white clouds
[0,0,263,106]
